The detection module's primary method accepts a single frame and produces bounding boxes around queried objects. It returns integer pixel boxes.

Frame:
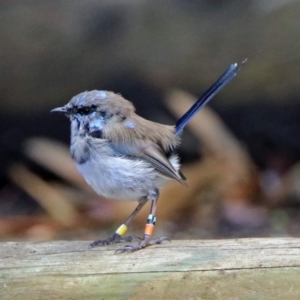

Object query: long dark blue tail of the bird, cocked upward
[175,59,247,135]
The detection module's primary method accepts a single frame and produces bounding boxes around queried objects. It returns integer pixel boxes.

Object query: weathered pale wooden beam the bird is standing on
[0,238,300,300]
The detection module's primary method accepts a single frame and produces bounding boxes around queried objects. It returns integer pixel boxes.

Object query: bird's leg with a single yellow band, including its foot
[90,198,148,248]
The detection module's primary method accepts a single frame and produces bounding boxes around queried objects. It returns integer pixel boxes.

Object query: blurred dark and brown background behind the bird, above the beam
[0,0,300,241]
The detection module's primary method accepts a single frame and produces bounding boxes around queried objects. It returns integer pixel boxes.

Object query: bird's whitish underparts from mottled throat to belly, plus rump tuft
[71,131,180,200]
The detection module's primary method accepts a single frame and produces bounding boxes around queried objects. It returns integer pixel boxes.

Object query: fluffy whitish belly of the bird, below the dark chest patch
[76,157,161,200]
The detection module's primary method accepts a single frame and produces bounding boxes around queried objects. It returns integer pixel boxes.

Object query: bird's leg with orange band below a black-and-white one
[116,189,169,253]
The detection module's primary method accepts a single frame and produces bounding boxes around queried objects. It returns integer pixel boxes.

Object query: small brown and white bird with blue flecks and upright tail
[51,62,244,252]
